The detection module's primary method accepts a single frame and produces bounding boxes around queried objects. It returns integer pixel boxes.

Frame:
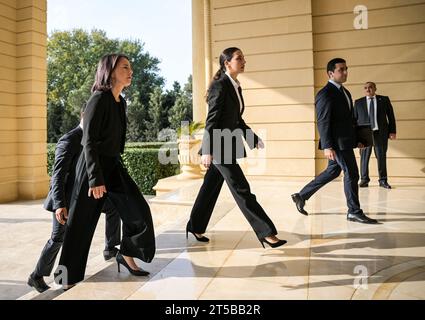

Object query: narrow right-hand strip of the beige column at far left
[16,0,49,199]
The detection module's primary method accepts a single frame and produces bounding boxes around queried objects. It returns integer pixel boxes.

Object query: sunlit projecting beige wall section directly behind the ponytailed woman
[192,0,315,177]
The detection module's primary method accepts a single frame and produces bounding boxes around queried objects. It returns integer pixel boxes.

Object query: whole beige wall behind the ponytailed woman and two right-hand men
[192,0,425,181]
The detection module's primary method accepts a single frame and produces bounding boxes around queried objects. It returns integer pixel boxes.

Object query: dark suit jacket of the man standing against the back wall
[354,95,396,139]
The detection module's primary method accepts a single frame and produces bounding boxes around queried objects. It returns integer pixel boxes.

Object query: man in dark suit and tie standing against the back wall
[354,81,396,189]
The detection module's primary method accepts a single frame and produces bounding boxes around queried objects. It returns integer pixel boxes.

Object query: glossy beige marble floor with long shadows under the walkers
[0,180,425,300]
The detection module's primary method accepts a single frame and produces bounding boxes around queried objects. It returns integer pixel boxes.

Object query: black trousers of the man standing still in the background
[360,131,388,182]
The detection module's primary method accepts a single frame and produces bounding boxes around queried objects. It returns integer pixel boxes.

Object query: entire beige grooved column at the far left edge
[0,0,48,202]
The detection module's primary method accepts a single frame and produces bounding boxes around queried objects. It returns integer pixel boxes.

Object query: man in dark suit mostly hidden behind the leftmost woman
[28,112,121,292]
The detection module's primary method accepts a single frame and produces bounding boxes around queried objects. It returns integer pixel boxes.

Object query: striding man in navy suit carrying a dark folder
[292,58,377,224]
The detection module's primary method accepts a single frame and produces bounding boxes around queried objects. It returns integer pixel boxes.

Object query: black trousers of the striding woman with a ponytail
[188,163,277,239]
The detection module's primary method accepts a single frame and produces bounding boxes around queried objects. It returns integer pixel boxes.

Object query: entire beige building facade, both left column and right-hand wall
[0,0,425,202]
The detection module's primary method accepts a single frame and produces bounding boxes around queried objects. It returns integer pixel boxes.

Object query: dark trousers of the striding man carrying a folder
[299,149,363,213]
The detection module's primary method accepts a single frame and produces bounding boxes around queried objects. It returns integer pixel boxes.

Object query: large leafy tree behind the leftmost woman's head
[47,29,164,142]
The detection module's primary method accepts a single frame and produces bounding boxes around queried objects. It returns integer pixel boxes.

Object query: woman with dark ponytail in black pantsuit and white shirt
[186,47,286,248]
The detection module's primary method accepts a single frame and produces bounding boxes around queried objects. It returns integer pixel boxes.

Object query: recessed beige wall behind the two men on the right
[312,0,425,180]
